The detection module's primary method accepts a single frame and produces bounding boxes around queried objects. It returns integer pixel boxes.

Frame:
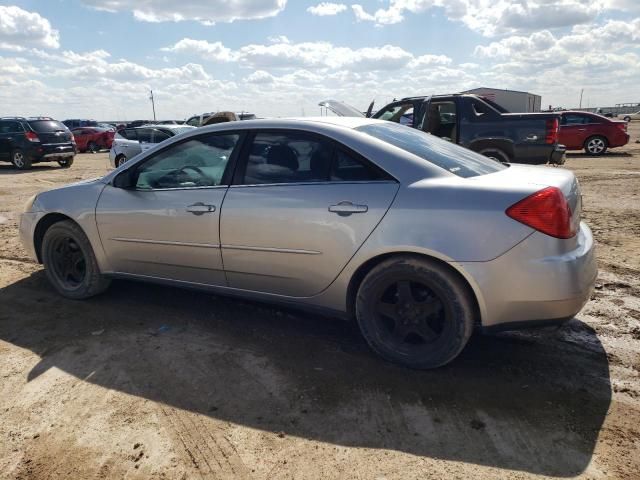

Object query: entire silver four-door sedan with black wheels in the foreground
[20,117,597,368]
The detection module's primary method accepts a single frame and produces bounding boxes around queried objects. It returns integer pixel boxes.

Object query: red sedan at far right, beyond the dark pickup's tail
[558,112,629,155]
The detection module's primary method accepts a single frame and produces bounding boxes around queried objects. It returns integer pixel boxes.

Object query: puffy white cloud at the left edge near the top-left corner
[0,5,60,51]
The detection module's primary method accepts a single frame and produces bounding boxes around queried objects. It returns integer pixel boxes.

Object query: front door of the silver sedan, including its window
[96,133,240,285]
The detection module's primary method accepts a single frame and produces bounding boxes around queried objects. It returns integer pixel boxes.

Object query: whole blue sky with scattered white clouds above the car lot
[0,0,640,120]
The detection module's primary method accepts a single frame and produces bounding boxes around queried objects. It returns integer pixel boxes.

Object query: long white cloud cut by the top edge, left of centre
[81,0,287,25]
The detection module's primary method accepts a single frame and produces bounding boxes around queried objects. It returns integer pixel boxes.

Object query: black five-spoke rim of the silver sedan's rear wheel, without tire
[375,279,449,350]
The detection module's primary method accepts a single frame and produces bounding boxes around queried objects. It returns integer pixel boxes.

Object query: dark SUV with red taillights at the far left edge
[0,117,76,170]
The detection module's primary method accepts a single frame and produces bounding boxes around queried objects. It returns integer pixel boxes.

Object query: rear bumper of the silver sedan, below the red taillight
[459,223,598,330]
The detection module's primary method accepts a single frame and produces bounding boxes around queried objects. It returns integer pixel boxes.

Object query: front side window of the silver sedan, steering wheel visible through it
[136,134,240,190]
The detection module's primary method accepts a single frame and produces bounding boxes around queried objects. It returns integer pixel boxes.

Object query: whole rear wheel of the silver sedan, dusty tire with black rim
[356,256,475,369]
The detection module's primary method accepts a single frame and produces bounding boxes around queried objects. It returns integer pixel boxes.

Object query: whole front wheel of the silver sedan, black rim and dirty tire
[42,220,111,300]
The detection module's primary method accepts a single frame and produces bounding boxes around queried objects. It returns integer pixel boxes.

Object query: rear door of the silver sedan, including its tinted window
[220,130,398,297]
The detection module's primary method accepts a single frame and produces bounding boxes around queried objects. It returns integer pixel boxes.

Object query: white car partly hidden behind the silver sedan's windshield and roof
[109,125,196,168]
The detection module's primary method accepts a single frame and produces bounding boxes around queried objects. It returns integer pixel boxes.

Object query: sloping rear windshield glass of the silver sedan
[356,123,507,178]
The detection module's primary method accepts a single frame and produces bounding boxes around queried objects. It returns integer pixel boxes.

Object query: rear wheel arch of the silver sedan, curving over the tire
[346,251,484,327]
